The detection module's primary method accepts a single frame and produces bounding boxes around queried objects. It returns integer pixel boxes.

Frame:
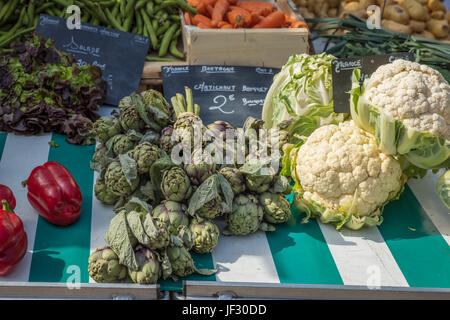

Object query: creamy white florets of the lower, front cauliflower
[296,121,404,216]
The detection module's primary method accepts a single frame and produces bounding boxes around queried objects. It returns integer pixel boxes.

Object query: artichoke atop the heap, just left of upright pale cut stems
[141,89,174,127]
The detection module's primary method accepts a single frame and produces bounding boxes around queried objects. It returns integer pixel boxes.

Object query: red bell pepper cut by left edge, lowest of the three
[0,200,28,276]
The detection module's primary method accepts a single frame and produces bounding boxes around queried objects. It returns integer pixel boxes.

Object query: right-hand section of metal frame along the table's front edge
[172,281,450,300]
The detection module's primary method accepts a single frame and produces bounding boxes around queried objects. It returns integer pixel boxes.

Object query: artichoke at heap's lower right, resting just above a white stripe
[226,194,264,235]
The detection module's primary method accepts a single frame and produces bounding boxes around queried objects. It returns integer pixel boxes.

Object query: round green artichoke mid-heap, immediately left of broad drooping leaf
[161,167,192,201]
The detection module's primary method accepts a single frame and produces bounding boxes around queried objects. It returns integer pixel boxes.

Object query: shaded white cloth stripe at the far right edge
[408,170,450,245]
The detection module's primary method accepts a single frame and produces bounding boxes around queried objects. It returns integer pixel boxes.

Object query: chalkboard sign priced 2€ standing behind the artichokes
[161,66,280,127]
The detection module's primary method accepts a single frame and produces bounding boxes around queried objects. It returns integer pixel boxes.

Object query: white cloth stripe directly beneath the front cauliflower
[319,222,408,288]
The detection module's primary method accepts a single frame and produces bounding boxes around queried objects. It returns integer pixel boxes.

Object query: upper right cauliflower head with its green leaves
[350,59,450,170]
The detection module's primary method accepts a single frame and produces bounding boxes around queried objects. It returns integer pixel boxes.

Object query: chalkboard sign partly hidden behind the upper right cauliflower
[331,52,414,113]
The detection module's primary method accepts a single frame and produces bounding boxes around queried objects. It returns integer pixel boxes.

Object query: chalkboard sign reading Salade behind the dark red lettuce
[36,15,150,105]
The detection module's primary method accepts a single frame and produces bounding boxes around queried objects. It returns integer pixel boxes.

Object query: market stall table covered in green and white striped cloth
[0,127,450,299]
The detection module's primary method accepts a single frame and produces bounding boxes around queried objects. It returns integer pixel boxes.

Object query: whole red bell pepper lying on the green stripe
[27,161,82,226]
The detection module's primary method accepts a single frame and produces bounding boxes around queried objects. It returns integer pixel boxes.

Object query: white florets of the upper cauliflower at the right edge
[364,59,450,140]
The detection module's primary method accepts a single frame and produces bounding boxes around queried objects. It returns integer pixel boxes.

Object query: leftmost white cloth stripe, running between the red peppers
[0,133,52,282]
